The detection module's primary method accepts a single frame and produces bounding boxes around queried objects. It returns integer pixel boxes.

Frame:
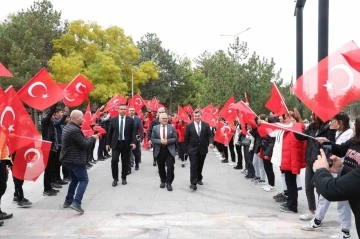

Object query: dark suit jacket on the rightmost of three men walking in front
[184,121,214,155]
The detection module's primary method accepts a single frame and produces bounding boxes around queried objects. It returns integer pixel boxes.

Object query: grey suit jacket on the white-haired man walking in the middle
[151,124,177,158]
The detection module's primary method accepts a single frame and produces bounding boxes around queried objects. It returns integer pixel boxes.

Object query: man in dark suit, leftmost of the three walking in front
[106,105,136,187]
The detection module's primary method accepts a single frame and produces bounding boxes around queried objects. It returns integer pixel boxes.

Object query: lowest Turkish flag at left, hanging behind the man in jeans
[12,139,51,181]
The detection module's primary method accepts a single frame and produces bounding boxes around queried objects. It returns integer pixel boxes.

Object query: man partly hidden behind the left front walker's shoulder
[129,107,144,173]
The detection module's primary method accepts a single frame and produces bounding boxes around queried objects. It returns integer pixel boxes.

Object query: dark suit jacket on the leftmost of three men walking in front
[106,116,136,149]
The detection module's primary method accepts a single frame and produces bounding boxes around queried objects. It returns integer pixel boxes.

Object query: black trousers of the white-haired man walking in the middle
[156,146,175,185]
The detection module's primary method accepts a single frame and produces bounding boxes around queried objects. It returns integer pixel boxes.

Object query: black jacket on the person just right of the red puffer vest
[294,123,336,167]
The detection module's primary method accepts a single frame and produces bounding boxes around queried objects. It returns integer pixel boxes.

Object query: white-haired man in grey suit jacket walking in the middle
[151,113,177,191]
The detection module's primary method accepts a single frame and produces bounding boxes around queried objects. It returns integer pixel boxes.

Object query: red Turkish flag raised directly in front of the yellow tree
[64,74,94,107]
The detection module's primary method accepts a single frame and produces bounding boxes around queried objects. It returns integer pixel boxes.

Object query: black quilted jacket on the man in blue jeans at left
[60,122,96,165]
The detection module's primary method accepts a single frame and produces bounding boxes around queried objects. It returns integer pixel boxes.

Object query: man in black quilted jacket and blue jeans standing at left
[60,110,99,213]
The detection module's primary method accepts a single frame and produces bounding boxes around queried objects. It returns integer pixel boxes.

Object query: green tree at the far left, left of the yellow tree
[0,0,64,89]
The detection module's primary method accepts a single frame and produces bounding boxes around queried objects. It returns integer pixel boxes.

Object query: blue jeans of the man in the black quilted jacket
[64,163,89,205]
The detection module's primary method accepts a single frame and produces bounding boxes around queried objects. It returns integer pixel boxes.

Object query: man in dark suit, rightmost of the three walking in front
[184,110,214,191]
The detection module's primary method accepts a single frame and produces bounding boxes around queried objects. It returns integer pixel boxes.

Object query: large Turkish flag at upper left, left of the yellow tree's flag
[17,68,64,110]
